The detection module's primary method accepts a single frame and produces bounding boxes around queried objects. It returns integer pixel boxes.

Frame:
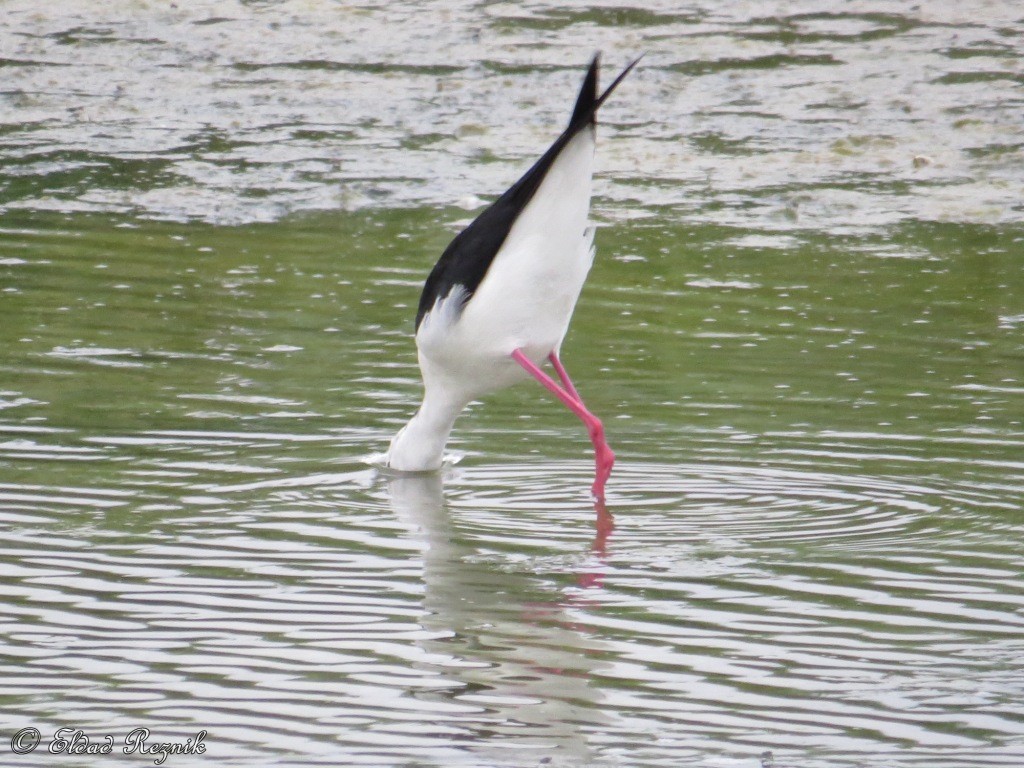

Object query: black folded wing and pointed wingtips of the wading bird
[416,54,640,331]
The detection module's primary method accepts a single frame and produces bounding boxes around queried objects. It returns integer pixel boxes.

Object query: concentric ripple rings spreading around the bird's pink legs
[451,461,946,544]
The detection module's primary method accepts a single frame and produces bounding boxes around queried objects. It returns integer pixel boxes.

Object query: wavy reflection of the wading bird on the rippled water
[387,473,613,764]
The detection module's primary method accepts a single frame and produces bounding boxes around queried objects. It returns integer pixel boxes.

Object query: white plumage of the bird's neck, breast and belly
[388,126,595,471]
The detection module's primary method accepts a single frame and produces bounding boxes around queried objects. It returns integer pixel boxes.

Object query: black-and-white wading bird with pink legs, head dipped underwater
[385,53,640,502]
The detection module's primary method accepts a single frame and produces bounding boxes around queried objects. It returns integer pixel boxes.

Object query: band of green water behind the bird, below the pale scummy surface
[6,210,1024,471]
